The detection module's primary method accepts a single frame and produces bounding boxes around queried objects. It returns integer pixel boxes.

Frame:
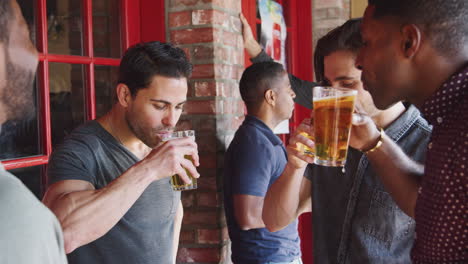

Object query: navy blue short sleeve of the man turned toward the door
[231,142,275,197]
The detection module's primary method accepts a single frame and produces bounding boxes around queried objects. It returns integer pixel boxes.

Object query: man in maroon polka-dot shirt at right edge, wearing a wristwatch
[351,0,468,263]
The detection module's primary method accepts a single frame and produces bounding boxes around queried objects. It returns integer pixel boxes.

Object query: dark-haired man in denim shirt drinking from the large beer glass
[243,16,430,263]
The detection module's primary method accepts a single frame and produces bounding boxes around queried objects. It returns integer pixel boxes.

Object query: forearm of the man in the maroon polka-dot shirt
[367,133,424,218]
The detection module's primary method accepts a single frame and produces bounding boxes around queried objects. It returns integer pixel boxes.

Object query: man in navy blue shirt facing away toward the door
[224,62,310,264]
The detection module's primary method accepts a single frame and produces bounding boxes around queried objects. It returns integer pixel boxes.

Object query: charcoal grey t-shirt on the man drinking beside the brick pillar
[47,121,180,264]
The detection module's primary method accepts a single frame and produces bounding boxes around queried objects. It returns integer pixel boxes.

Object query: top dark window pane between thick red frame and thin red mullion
[47,0,83,55]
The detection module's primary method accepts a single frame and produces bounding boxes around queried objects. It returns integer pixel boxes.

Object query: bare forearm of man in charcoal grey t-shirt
[50,164,152,253]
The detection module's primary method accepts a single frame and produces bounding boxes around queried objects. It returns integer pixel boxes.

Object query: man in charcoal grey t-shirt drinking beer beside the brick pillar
[44,41,203,264]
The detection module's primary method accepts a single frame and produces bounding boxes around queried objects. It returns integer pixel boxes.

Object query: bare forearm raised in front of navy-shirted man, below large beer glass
[262,163,305,231]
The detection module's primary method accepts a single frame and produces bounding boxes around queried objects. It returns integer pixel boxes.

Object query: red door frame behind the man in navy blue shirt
[242,0,313,264]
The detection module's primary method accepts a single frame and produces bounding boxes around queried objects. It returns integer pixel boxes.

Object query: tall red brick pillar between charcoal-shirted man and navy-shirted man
[166,0,244,263]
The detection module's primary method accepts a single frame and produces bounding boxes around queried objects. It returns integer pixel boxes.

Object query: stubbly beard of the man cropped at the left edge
[0,53,36,120]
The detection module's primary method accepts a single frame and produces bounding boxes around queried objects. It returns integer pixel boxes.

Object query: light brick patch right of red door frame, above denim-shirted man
[312,0,351,47]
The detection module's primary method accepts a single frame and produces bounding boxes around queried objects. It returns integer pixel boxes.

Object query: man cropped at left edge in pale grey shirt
[0,0,67,264]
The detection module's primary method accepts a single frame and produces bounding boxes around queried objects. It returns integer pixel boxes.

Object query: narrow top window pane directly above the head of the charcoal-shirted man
[93,0,122,58]
